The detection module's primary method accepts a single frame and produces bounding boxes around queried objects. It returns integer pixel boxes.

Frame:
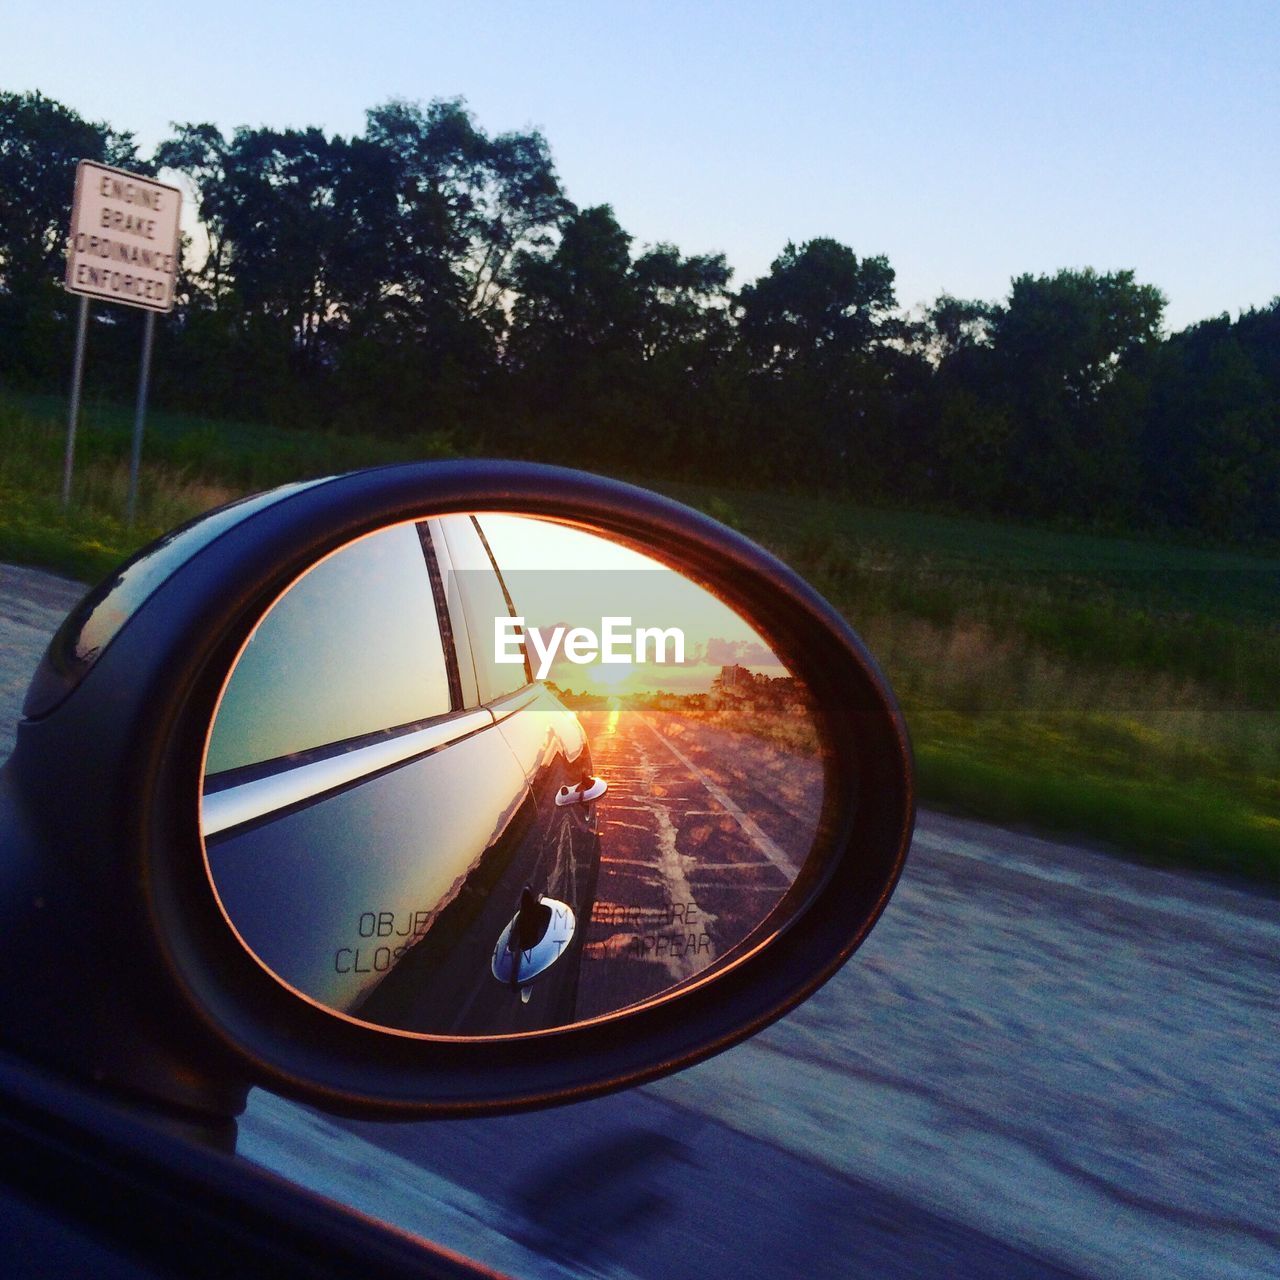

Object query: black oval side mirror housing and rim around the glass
[0,461,914,1117]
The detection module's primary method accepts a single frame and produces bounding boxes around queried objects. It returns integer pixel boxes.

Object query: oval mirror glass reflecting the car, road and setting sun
[201,513,824,1037]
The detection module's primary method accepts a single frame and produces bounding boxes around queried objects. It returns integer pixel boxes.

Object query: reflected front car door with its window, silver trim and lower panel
[204,514,525,1012]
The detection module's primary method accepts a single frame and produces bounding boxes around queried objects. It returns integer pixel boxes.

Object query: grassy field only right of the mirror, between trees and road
[666,486,1280,888]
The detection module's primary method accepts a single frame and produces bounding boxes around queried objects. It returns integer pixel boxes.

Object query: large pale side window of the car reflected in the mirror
[206,525,451,773]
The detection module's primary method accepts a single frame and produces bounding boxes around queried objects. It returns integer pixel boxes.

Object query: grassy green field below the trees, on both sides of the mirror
[0,396,1280,887]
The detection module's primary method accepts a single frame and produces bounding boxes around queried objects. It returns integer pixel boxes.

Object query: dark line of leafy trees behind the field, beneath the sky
[0,93,1280,541]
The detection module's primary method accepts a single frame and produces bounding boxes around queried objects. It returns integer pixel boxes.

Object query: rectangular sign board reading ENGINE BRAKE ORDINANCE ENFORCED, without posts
[67,160,182,311]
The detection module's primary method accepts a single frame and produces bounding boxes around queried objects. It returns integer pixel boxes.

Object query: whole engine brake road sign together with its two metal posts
[63,160,182,517]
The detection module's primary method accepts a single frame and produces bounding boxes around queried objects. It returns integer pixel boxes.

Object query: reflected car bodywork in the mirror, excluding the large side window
[204,520,598,1034]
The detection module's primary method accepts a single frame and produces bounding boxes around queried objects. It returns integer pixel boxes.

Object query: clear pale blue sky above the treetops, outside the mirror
[0,0,1280,329]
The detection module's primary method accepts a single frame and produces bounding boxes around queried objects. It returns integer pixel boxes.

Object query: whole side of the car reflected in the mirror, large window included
[204,514,599,1033]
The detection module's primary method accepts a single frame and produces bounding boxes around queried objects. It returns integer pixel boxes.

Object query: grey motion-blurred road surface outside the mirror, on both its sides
[0,567,1280,1280]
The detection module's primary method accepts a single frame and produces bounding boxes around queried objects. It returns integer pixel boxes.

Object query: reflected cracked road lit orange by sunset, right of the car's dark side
[577,704,820,1018]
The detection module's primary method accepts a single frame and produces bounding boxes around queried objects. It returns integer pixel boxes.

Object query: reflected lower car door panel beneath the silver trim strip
[206,717,527,1012]
